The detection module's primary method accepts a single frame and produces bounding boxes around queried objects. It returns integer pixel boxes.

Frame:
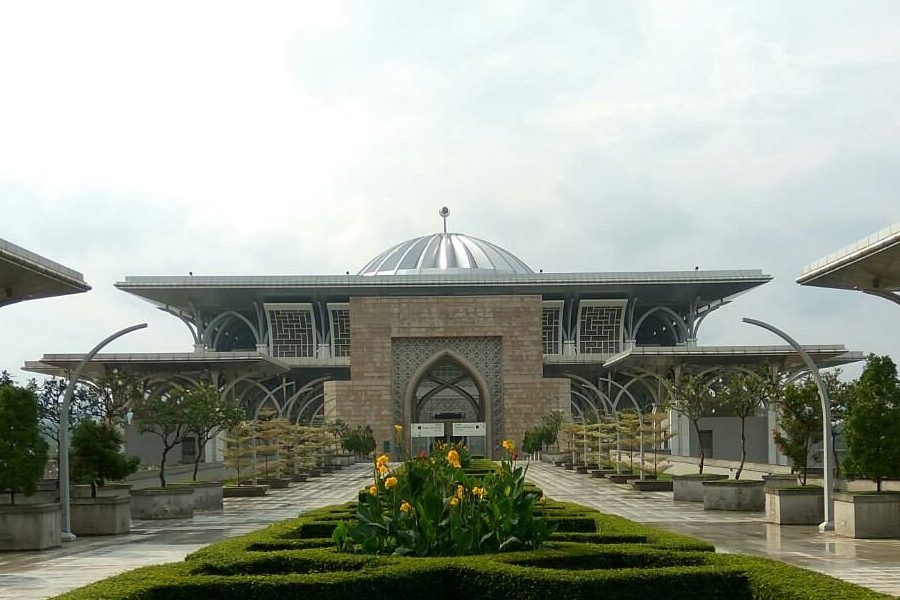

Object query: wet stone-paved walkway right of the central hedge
[528,463,900,596]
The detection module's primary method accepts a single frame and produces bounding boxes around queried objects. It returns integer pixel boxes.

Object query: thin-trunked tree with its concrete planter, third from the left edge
[131,389,194,519]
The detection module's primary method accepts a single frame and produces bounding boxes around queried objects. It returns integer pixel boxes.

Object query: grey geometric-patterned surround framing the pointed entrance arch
[391,337,503,448]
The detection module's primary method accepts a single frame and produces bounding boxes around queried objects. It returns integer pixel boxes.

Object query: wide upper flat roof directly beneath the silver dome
[116,270,772,312]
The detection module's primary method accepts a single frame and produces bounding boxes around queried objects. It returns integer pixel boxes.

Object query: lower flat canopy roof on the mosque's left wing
[24,352,290,377]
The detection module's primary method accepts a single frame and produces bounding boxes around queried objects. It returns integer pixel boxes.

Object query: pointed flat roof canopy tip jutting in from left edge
[0,239,91,306]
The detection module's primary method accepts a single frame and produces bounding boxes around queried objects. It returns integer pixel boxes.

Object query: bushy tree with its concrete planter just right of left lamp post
[71,419,140,535]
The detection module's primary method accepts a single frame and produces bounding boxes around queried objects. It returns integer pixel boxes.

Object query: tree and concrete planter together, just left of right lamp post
[764,378,825,525]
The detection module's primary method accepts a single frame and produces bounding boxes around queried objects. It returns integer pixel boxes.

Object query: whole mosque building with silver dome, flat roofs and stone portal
[26,208,860,463]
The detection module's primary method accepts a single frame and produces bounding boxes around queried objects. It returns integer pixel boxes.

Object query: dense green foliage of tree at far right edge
[844,354,900,491]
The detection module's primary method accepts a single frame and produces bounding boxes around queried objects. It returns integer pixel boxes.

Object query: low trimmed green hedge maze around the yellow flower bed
[52,501,890,600]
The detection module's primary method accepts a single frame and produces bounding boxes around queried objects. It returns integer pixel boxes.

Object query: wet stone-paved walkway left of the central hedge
[0,464,372,600]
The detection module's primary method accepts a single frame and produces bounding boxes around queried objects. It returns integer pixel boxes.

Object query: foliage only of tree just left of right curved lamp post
[772,378,822,485]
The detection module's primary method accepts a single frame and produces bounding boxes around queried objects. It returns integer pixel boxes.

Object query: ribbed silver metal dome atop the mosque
[357,233,534,275]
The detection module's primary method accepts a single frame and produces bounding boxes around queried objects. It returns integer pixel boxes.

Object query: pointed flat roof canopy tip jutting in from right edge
[797,223,900,292]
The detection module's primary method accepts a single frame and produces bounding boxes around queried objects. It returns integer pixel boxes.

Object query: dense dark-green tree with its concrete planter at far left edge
[0,383,62,550]
